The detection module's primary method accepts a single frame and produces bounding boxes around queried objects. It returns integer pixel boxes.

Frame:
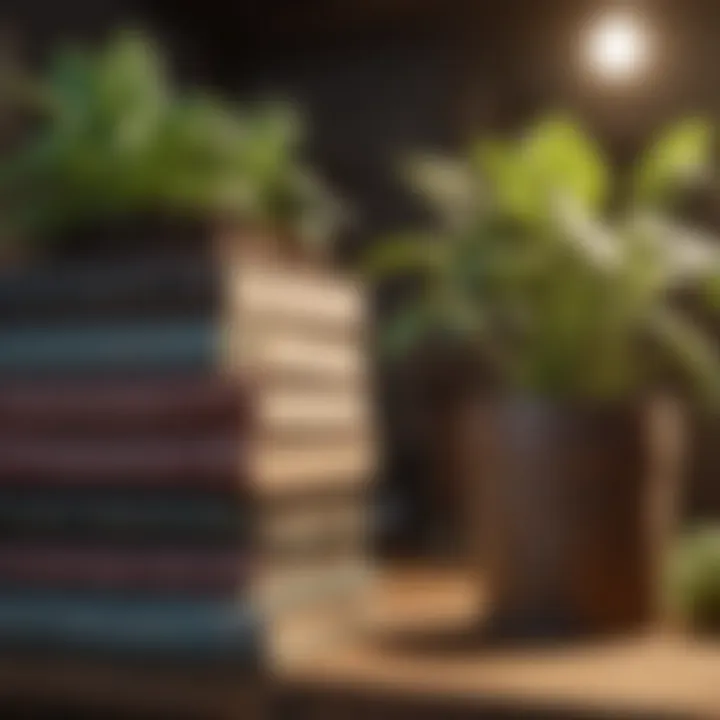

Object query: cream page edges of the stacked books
[233,265,378,666]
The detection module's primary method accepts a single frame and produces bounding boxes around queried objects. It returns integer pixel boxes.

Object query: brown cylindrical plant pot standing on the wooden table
[474,399,679,639]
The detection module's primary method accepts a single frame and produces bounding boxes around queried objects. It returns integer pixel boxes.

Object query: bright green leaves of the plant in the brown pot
[366,118,720,400]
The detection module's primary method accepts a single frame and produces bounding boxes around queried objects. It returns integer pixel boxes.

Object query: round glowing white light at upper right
[586,11,650,82]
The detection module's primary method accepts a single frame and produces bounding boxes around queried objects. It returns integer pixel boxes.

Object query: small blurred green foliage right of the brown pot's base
[669,526,720,635]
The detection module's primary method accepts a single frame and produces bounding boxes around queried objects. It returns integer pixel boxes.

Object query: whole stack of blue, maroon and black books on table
[0,252,374,708]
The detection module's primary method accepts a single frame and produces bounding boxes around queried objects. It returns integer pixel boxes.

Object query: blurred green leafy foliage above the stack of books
[0,31,339,249]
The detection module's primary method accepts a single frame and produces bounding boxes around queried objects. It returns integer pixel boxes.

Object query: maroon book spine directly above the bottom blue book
[0,542,250,597]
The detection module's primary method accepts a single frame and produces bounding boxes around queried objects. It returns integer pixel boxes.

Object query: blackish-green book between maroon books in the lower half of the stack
[0,486,394,552]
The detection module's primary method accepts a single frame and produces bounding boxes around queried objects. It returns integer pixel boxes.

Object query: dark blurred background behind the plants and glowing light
[0,0,720,546]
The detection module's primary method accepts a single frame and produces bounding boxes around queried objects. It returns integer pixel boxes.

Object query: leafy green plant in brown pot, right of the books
[367,117,720,637]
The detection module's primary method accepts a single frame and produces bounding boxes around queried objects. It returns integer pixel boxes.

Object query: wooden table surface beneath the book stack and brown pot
[0,569,720,720]
